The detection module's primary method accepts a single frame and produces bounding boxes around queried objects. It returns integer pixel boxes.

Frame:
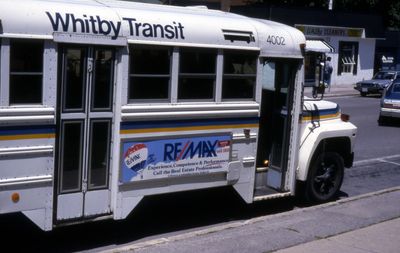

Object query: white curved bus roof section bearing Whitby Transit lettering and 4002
[0,0,305,58]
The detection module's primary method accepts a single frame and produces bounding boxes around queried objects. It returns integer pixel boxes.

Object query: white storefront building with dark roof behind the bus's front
[231,5,385,86]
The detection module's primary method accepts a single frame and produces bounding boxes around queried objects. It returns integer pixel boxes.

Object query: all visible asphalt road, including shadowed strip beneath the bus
[0,94,400,252]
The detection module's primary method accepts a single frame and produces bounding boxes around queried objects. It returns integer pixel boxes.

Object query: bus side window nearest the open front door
[222,50,257,99]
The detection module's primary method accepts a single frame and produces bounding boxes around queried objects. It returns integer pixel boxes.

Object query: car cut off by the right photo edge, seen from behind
[378,79,400,125]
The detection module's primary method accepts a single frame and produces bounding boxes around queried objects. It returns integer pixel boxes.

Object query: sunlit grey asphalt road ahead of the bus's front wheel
[329,96,400,200]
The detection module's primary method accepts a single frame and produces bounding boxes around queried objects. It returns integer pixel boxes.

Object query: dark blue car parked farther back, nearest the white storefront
[354,71,400,97]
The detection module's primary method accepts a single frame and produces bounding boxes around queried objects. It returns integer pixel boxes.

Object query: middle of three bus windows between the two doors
[178,48,217,100]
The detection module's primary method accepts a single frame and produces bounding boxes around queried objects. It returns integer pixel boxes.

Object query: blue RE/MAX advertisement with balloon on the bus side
[121,135,231,183]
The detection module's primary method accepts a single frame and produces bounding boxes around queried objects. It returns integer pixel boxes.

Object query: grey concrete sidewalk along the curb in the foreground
[103,187,400,253]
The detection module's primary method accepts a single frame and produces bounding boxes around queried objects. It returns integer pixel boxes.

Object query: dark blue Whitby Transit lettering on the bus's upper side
[46,12,185,40]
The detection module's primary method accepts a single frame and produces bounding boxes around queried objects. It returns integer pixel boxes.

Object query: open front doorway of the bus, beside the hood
[255,59,299,197]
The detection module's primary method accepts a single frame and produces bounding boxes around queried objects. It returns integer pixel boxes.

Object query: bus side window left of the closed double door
[9,39,44,105]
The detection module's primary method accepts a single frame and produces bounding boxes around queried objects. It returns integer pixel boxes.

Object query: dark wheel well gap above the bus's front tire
[311,137,353,168]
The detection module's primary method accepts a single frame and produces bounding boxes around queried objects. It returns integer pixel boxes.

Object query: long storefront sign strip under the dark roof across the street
[295,25,364,38]
